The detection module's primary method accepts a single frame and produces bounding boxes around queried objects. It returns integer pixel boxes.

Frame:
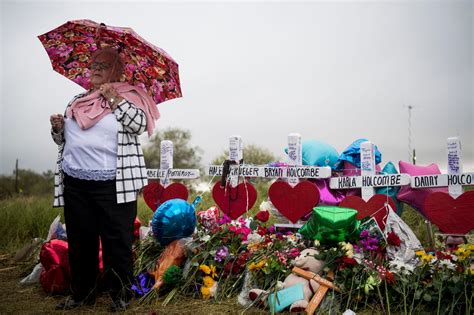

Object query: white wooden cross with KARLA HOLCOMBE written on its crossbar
[329,141,410,201]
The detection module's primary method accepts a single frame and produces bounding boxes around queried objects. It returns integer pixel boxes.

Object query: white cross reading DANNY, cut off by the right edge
[410,137,474,198]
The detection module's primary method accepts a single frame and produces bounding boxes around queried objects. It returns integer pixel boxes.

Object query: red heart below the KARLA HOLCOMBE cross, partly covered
[339,194,397,231]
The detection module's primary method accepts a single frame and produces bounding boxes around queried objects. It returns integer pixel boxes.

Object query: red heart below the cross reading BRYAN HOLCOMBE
[268,180,319,223]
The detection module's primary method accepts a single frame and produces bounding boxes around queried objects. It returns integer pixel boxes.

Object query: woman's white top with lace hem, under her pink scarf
[62,113,119,180]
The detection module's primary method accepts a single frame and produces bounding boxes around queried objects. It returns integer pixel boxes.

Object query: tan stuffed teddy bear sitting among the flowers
[249,248,324,312]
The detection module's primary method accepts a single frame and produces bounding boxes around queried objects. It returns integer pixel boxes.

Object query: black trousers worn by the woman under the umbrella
[64,174,137,300]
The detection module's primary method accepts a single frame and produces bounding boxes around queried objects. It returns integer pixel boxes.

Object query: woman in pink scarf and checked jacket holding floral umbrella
[50,48,159,311]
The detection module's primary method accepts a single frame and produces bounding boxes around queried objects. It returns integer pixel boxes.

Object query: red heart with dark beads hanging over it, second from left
[212,182,257,220]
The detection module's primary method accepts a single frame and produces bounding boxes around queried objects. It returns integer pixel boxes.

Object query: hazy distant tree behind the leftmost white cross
[143,127,202,168]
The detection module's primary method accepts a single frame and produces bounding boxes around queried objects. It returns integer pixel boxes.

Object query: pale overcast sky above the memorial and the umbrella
[0,1,474,174]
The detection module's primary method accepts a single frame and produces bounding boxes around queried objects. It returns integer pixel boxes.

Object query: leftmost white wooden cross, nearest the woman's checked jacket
[147,140,200,187]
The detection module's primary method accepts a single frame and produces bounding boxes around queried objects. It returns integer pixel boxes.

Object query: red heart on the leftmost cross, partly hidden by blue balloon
[143,182,188,212]
